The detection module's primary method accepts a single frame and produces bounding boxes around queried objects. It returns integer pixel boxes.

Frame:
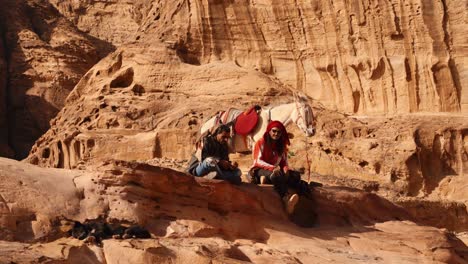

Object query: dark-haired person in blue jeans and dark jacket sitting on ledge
[187,125,242,184]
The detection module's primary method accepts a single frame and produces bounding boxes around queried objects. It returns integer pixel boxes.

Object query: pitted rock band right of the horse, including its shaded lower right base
[290,108,468,231]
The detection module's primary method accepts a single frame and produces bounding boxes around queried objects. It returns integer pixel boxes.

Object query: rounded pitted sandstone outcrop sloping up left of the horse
[28,44,293,168]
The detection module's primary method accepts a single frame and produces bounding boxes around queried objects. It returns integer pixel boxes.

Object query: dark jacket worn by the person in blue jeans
[186,135,229,175]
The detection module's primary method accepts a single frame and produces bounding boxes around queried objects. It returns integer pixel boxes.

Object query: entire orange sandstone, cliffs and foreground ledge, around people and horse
[0,0,468,263]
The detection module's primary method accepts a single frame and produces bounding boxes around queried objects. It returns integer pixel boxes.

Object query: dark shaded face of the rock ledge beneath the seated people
[89,160,418,242]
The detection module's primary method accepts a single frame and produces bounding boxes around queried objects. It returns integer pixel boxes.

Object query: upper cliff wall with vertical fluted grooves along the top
[47,0,468,114]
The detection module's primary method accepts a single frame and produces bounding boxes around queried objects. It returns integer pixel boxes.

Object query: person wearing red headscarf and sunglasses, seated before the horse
[250,121,300,214]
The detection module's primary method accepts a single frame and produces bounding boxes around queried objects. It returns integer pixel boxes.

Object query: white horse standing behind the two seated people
[200,97,315,152]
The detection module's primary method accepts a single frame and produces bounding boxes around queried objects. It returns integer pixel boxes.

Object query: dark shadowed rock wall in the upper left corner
[0,0,105,159]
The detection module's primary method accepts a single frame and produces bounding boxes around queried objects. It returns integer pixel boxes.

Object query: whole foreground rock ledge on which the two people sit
[0,158,468,264]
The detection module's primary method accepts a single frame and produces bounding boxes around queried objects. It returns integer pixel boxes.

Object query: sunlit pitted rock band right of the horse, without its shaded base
[298,111,468,198]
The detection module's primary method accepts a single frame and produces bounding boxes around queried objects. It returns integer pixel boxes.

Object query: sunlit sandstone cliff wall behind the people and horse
[21,0,468,233]
